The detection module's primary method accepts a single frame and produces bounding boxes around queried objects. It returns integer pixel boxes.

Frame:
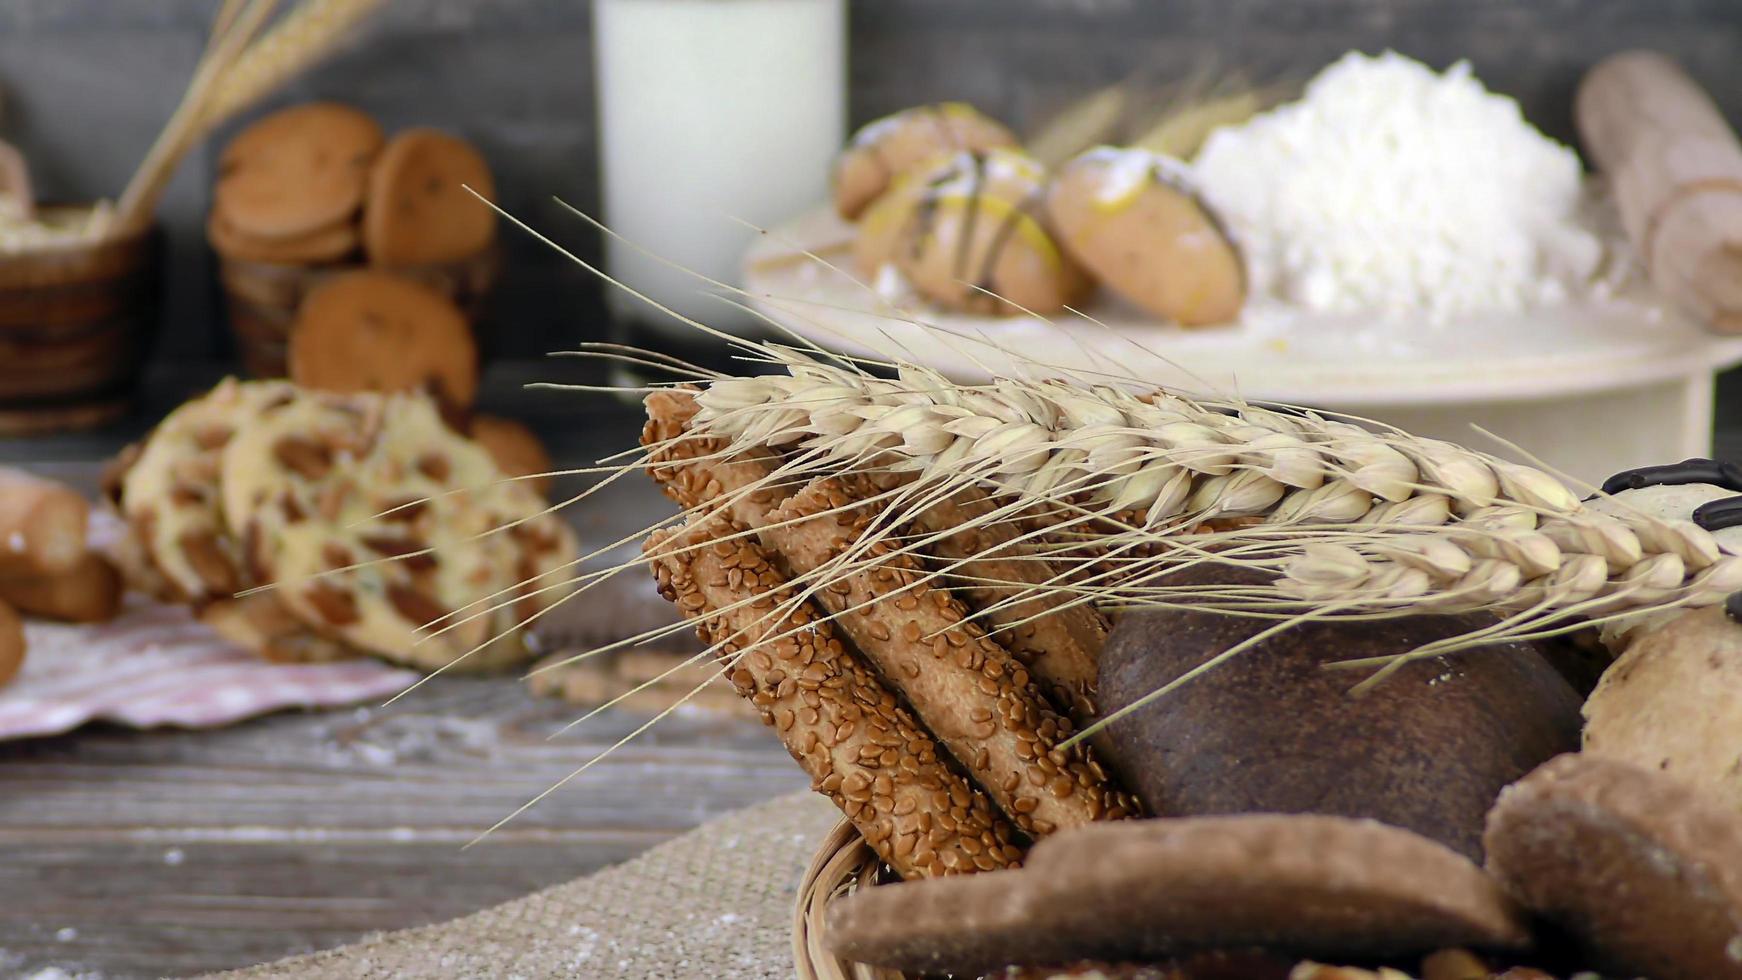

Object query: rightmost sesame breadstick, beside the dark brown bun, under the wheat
[869,473,1108,724]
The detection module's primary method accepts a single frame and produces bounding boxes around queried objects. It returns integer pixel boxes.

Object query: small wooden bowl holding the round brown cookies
[218,244,502,378]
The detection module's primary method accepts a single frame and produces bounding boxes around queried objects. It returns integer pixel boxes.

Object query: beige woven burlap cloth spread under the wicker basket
[213,792,840,980]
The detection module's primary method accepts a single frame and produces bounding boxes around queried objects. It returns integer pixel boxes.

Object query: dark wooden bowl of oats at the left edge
[0,209,160,435]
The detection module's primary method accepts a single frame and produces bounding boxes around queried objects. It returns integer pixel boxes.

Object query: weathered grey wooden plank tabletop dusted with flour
[0,384,805,978]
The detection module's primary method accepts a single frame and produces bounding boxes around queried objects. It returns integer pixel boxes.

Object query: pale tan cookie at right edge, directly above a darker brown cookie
[1583,606,1742,816]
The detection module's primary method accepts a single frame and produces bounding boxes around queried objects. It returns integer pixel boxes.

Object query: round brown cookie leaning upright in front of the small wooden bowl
[287,270,477,411]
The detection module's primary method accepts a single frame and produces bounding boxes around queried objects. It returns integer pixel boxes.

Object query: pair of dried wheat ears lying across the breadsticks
[672,345,1742,675]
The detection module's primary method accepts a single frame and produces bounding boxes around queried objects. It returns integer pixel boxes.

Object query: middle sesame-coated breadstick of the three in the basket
[758,477,1141,837]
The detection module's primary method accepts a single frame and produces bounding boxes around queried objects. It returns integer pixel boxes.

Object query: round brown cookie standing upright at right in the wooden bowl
[362,129,496,266]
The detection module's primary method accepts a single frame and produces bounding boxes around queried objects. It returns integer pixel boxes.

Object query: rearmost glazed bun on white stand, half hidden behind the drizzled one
[831,103,1017,221]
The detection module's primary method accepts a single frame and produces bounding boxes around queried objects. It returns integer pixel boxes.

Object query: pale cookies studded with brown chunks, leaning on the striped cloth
[118,379,577,670]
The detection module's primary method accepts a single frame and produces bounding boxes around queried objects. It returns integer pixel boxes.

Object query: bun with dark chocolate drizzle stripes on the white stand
[854,148,1089,315]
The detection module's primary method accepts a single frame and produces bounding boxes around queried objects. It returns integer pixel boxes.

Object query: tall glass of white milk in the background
[592,0,847,341]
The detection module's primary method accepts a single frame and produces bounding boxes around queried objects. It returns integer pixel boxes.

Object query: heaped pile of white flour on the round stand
[1193,52,1604,319]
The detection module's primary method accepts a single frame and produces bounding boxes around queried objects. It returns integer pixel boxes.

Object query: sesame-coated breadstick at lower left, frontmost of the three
[643,517,1023,877]
